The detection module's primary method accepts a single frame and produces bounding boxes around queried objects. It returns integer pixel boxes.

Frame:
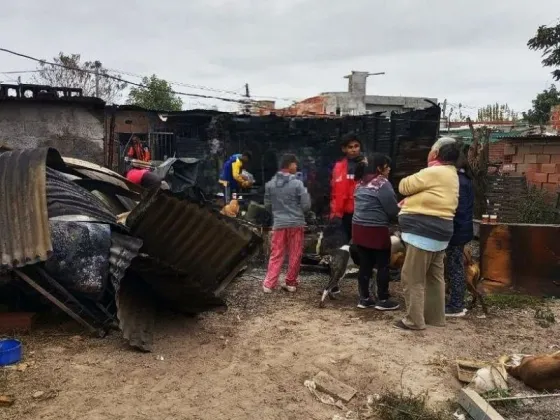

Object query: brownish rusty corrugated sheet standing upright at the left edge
[0,148,64,269]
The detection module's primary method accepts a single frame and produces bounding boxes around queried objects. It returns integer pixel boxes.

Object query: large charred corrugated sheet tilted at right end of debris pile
[126,190,262,309]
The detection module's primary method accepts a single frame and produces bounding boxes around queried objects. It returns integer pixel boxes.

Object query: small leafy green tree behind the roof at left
[127,74,183,111]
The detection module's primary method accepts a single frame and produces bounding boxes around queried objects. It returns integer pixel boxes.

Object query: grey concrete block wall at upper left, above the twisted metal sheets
[0,100,105,165]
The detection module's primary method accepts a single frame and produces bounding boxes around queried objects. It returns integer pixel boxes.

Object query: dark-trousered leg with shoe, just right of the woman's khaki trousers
[445,245,466,316]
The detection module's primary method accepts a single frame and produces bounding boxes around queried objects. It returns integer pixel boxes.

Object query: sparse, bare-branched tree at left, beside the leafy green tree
[33,52,126,103]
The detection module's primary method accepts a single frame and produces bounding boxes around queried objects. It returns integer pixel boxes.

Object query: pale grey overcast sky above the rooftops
[0,0,560,115]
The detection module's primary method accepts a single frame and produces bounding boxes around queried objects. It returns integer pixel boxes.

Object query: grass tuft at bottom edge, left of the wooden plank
[375,391,453,420]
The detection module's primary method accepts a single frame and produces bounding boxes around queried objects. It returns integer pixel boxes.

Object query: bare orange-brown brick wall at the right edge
[504,141,560,194]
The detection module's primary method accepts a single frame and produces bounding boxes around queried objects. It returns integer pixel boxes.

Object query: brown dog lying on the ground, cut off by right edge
[507,351,560,391]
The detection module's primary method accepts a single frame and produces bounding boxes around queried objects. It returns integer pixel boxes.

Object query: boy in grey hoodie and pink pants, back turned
[263,155,311,293]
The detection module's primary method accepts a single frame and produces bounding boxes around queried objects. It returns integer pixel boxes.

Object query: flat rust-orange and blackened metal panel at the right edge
[480,224,560,296]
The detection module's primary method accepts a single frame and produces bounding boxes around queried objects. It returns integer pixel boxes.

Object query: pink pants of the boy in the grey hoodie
[263,227,304,289]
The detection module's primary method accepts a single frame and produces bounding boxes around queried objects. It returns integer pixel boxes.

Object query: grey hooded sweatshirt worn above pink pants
[264,172,311,229]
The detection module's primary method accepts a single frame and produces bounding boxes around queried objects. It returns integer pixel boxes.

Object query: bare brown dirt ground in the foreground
[0,270,560,420]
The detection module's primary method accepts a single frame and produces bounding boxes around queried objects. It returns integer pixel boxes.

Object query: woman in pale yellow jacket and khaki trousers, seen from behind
[395,137,460,330]
